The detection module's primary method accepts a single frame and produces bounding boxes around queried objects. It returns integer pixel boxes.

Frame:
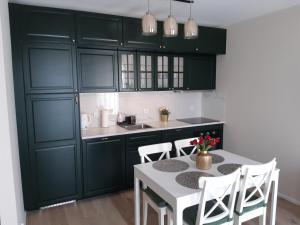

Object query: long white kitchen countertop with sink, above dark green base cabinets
[81,120,224,140]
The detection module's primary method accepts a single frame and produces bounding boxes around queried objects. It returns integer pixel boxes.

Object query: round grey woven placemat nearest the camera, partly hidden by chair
[176,171,214,189]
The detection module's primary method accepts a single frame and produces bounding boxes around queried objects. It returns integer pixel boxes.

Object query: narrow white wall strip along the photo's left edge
[0,0,25,225]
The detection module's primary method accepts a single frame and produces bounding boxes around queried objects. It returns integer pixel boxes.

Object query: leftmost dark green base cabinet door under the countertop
[83,136,125,197]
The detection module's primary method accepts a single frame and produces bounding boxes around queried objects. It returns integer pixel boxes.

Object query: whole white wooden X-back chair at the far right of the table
[234,159,276,225]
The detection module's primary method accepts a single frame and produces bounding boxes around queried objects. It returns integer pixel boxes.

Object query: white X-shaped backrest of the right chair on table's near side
[236,159,276,213]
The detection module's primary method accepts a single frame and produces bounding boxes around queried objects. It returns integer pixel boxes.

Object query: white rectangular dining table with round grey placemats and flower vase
[134,150,279,225]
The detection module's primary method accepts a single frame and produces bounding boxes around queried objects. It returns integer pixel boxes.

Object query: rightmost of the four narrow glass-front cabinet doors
[172,56,184,90]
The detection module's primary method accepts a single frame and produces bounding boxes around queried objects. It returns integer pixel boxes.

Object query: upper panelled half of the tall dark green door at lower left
[26,94,79,148]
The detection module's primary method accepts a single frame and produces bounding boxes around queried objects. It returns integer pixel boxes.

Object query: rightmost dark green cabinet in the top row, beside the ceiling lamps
[195,26,226,54]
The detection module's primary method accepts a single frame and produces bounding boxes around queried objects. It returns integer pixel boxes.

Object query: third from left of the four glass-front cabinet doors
[156,55,171,90]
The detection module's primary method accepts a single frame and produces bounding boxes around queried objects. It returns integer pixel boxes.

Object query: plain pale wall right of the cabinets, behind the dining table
[214,6,300,203]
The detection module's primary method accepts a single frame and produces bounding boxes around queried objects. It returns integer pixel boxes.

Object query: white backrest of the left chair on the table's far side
[138,142,172,163]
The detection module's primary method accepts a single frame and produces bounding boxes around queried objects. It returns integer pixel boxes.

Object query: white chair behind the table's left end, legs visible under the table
[138,143,172,225]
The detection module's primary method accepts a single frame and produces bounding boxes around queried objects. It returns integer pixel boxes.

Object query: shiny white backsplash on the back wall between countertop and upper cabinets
[80,92,202,127]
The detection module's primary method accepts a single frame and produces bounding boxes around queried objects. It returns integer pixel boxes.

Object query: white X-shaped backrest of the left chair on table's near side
[196,169,241,225]
